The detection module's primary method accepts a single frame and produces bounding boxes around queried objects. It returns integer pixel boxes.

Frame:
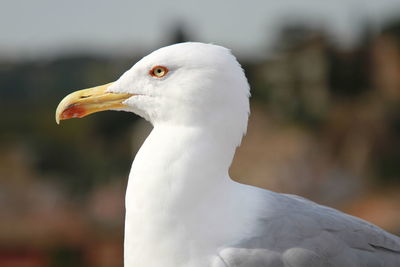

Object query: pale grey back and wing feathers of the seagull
[219,196,400,267]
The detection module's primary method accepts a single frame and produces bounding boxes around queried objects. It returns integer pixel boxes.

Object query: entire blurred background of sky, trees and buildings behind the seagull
[0,0,400,267]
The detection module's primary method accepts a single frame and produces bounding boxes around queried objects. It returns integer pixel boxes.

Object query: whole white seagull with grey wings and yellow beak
[56,42,400,267]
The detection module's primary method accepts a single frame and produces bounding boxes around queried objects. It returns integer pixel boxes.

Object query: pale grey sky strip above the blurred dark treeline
[0,0,400,59]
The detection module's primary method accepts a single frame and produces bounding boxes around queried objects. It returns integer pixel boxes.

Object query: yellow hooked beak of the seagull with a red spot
[56,83,133,124]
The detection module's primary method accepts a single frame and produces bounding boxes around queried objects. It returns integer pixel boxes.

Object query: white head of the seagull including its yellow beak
[56,43,249,144]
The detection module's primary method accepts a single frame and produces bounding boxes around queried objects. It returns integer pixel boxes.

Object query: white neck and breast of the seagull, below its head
[125,126,255,266]
